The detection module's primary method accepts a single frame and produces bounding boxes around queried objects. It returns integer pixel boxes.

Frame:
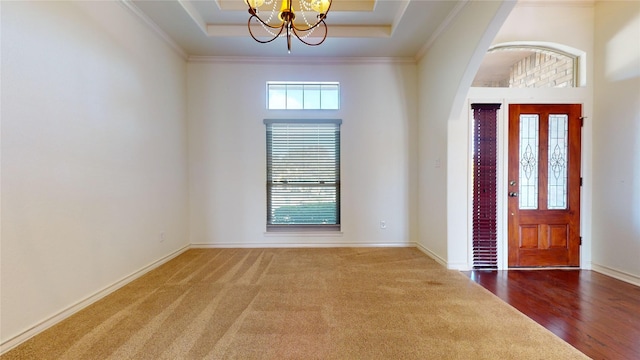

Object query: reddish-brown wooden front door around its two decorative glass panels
[507,103,582,268]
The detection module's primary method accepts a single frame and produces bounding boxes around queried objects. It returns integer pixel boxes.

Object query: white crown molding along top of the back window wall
[188,56,416,65]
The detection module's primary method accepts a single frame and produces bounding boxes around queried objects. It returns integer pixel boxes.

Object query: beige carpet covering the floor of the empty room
[1,248,586,360]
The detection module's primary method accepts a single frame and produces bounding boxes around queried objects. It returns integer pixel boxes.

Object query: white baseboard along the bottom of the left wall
[0,245,189,355]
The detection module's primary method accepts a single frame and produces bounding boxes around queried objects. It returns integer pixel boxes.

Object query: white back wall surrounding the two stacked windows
[188,59,417,247]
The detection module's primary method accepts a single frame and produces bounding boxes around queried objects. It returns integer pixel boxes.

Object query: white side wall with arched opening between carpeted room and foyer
[418,1,514,268]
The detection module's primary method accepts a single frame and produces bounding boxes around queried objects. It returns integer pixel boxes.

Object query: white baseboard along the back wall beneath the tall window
[191,241,416,249]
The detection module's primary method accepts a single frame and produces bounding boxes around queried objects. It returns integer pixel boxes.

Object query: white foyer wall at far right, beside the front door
[593,1,640,285]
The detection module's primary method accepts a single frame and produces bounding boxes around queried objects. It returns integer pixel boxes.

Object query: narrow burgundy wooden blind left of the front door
[471,104,500,269]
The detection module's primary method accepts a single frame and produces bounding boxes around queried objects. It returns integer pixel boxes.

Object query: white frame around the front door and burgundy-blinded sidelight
[466,97,591,270]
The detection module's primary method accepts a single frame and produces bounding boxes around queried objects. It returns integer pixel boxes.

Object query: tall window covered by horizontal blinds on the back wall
[264,120,342,231]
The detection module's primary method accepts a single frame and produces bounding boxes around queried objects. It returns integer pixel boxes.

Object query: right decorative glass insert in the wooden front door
[547,114,569,210]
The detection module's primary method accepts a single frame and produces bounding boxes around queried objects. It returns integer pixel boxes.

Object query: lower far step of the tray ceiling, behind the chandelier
[206,24,392,38]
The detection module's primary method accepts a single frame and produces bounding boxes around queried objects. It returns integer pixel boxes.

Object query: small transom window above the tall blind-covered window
[267,81,340,110]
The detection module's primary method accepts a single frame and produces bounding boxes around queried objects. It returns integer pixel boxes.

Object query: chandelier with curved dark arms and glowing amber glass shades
[245,0,332,53]
